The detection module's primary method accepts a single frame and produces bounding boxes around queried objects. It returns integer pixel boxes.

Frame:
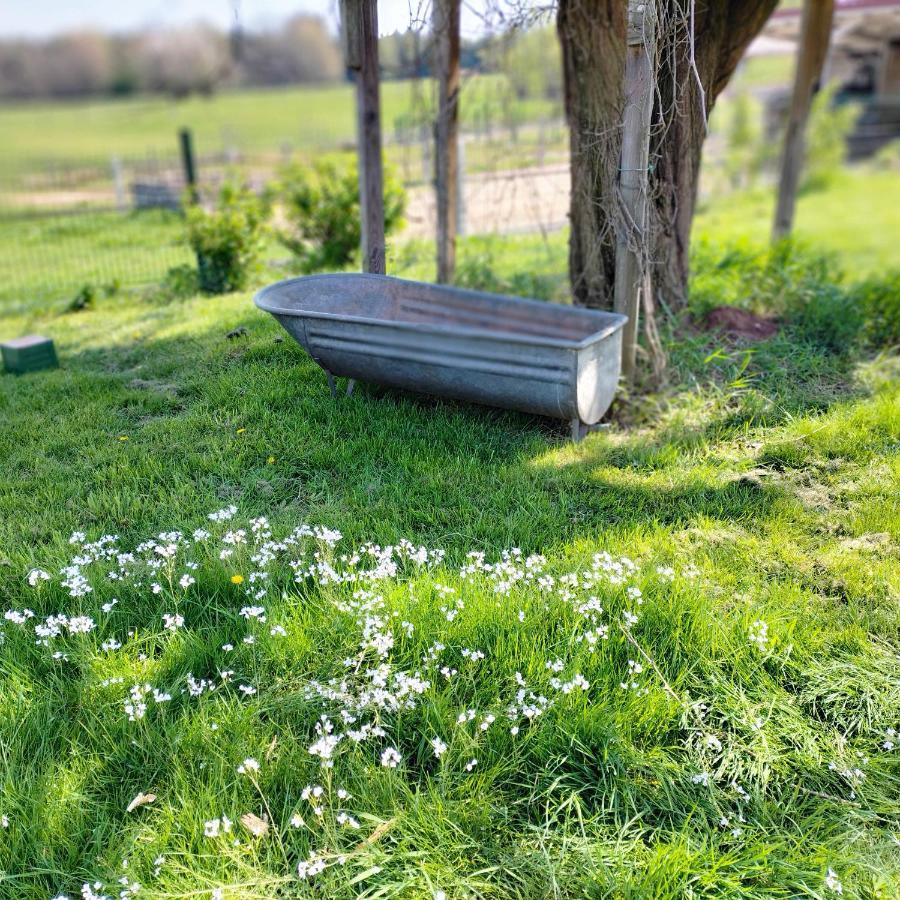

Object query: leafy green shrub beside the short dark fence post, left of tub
[187,184,268,294]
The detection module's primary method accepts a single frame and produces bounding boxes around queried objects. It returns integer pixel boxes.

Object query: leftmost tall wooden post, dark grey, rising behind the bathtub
[341,0,385,275]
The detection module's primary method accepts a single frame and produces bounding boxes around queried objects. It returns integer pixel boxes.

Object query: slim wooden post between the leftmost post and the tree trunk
[432,0,460,283]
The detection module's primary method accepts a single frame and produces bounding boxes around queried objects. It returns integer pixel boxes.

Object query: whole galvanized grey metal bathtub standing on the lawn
[254,274,626,440]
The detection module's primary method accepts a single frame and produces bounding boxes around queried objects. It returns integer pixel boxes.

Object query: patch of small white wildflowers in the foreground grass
[12,505,884,900]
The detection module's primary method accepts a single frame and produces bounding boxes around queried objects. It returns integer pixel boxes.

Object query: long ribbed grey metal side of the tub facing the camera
[276,313,578,419]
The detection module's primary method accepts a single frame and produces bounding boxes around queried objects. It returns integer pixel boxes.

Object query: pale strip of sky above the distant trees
[0,0,492,38]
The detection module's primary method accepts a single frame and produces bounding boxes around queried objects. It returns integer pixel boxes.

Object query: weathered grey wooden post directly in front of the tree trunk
[614,0,656,382]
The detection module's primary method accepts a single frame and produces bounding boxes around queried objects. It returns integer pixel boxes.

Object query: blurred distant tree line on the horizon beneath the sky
[0,15,561,100]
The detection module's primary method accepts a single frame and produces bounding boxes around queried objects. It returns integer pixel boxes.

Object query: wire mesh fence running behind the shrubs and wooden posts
[0,120,568,305]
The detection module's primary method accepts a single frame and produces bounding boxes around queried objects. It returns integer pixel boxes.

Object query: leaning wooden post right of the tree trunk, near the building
[772,0,834,241]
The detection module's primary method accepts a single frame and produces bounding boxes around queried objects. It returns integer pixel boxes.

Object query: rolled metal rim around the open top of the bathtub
[253,272,628,350]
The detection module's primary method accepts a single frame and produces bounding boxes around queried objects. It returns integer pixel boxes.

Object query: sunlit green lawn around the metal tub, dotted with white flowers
[0,167,900,900]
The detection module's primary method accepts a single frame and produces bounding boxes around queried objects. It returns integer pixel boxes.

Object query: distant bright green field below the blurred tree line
[0,76,561,175]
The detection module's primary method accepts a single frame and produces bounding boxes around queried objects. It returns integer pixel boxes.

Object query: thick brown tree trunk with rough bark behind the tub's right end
[557,0,777,309]
